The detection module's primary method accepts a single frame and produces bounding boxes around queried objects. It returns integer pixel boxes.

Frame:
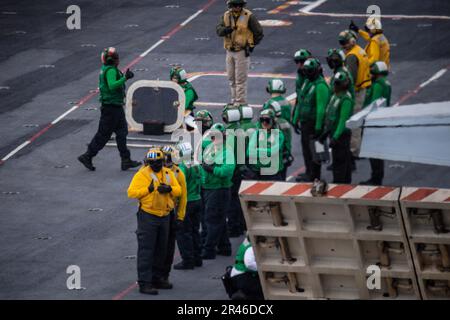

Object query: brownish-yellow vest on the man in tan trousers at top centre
[223,9,255,51]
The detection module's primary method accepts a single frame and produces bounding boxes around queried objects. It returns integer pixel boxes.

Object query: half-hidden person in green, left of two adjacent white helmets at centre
[222,104,245,238]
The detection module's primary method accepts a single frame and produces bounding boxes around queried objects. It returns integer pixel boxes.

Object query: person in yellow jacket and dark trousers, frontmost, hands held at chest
[128,148,181,295]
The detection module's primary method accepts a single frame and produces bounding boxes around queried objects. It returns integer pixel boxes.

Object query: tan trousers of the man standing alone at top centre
[226,50,250,104]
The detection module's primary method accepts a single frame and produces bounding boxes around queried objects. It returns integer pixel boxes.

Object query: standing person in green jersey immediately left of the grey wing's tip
[319,72,354,184]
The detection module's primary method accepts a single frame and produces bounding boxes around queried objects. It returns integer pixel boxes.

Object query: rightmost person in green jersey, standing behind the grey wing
[361,61,392,185]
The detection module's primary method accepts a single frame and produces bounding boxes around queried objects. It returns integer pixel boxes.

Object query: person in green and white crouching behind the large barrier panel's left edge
[223,236,264,300]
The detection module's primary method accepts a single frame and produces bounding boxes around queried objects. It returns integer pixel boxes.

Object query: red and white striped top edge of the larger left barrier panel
[240,181,400,201]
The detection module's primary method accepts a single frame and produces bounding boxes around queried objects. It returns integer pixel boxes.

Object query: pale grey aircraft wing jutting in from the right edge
[347,99,450,166]
